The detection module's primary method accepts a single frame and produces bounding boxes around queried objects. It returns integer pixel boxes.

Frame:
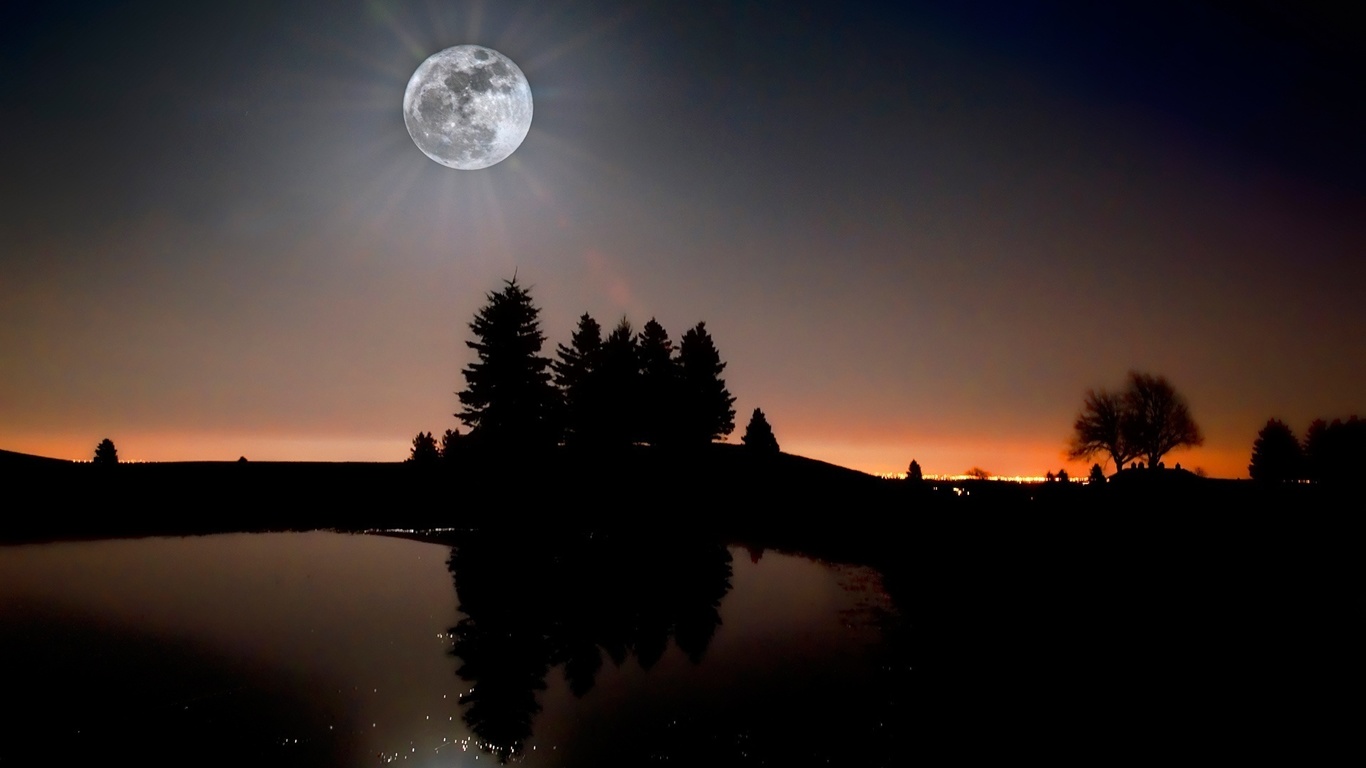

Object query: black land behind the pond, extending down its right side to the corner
[3,447,1366,763]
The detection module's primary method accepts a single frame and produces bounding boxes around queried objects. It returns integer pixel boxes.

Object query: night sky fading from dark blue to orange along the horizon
[0,0,1366,477]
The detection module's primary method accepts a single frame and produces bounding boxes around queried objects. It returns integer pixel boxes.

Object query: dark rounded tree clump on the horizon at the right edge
[1247,415,1366,482]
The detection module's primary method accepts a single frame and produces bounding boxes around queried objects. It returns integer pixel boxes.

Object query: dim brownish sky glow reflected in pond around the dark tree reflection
[0,533,896,765]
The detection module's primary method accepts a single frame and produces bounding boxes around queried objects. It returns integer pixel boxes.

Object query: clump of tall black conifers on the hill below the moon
[411,277,735,453]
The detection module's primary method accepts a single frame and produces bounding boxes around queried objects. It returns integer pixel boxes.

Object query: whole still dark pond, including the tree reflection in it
[0,532,896,767]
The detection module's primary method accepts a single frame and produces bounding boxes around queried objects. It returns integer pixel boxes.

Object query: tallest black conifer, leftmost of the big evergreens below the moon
[456,277,559,448]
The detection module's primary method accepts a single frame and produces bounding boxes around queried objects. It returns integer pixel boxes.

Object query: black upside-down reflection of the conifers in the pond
[448,532,731,761]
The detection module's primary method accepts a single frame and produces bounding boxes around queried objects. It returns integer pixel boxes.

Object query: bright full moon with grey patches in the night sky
[403,45,531,171]
